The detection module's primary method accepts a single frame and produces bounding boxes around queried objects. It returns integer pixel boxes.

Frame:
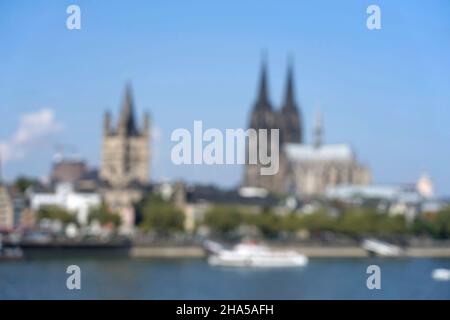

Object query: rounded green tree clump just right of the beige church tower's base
[137,194,184,235]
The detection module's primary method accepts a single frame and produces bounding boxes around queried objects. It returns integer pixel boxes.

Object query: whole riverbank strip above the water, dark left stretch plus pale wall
[6,240,450,258]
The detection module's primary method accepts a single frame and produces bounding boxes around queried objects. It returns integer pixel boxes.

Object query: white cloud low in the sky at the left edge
[0,108,63,162]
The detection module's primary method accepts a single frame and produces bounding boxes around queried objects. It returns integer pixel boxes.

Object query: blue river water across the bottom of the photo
[0,257,450,299]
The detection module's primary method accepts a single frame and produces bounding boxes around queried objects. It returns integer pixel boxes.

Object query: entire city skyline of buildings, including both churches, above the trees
[0,57,442,230]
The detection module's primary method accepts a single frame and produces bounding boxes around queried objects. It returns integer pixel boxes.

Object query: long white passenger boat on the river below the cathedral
[208,244,308,268]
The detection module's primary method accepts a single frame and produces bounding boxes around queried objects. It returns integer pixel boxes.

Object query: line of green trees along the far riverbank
[29,189,450,239]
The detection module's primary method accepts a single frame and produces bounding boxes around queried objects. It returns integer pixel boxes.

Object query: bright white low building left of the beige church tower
[30,183,101,225]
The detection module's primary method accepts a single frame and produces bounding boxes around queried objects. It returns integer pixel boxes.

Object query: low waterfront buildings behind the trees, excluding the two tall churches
[0,166,447,232]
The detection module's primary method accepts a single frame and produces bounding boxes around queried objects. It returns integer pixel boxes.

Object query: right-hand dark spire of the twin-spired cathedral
[279,61,303,144]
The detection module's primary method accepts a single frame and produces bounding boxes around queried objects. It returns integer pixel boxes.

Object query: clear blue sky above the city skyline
[0,0,450,195]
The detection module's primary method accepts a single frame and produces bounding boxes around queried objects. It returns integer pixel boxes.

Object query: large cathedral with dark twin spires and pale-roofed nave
[243,60,371,197]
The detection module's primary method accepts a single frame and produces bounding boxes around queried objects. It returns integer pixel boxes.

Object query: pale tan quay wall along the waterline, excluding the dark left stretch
[130,245,450,258]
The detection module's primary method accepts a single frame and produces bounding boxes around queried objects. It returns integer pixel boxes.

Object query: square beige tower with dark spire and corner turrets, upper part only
[100,85,150,188]
